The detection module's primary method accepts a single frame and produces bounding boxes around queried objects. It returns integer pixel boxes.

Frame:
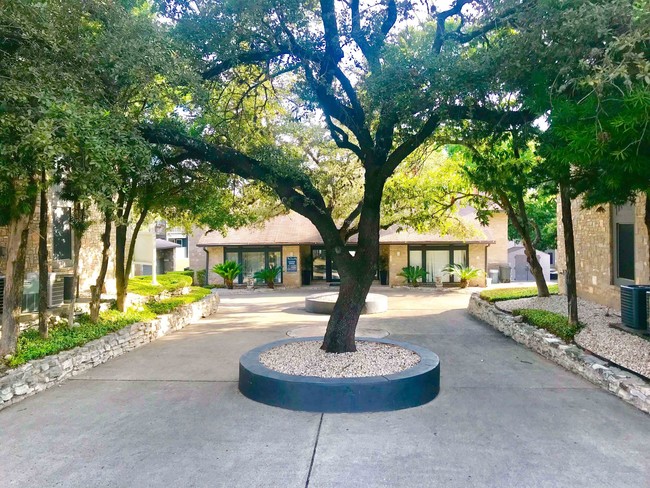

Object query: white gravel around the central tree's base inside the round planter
[260,340,420,378]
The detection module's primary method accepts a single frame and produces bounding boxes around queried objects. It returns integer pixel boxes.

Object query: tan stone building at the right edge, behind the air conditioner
[557,196,650,309]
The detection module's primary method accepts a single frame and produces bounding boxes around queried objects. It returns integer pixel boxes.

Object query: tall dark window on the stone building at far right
[612,204,635,285]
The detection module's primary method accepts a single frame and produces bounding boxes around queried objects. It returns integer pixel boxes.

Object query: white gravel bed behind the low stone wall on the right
[496,295,650,377]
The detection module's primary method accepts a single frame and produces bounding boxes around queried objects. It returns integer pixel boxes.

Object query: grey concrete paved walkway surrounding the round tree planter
[0,289,650,488]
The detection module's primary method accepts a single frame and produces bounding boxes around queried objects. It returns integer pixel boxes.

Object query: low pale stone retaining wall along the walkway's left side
[0,293,219,410]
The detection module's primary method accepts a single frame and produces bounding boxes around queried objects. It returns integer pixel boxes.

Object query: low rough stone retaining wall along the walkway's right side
[467,293,650,413]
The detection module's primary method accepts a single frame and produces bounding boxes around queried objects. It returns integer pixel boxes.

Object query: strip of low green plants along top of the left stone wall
[5,284,210,368]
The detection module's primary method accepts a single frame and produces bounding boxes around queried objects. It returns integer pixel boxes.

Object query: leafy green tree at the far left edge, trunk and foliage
[0,0,91,356]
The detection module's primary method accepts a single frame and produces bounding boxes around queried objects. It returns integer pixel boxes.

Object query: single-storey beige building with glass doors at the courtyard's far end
[195,209,508,287]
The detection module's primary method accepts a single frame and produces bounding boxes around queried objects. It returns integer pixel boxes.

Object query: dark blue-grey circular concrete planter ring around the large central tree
[239,337,440,413]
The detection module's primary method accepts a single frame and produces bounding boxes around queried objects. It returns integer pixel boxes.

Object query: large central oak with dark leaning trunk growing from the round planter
[149,0,529,352]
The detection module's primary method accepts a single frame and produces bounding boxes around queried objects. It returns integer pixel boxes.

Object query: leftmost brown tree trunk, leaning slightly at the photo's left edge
[0,212,34,357]
